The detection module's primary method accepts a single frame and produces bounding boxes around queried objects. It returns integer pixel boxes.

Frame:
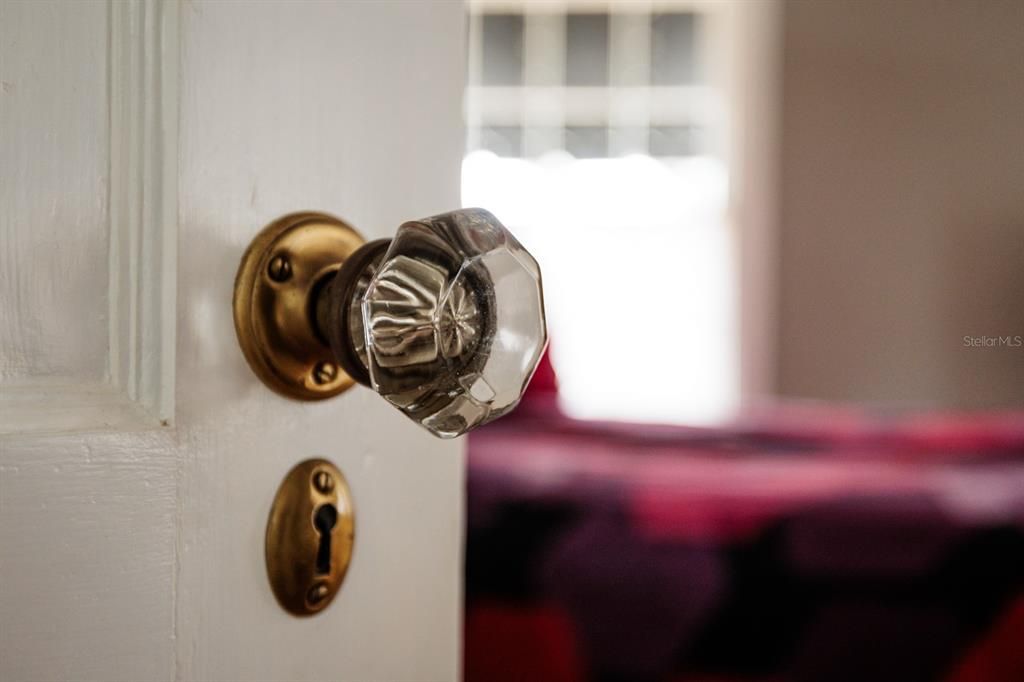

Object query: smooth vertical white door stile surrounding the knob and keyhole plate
[177,2,465,680]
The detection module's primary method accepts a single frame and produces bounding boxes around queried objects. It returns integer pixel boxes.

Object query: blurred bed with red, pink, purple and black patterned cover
[465,377,1024,682]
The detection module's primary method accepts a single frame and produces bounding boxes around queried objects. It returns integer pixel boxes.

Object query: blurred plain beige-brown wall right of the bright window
[776,0,1024,407]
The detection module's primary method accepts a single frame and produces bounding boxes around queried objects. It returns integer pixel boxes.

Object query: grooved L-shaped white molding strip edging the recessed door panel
[0,0,180,434]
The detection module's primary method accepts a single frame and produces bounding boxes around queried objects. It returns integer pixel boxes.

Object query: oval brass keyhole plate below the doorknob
[265,459,355,615]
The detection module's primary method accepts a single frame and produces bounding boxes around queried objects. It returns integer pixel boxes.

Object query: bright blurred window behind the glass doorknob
[463,0,738,423]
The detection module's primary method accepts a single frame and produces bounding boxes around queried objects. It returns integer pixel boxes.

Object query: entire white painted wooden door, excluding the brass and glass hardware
[0,0,465,680]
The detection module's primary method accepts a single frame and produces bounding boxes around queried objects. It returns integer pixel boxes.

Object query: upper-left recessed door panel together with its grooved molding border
[0,0,178,433]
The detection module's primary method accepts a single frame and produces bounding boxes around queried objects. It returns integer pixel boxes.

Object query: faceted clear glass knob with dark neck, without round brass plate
[316,209,547,437]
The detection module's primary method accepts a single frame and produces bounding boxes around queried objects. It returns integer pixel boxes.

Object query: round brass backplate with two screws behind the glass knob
[234,213,364,400]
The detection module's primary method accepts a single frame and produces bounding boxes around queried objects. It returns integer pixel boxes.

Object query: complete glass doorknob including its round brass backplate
[234,209,547,437]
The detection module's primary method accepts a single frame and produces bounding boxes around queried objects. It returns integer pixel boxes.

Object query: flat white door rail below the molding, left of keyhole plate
[0,429,178,682]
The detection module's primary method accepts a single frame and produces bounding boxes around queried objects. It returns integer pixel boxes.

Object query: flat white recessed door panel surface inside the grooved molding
[0,2,110,385]
